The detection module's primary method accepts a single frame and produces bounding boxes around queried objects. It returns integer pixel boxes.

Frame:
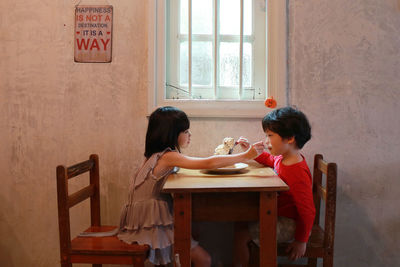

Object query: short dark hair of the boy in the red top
[262,107,311,149]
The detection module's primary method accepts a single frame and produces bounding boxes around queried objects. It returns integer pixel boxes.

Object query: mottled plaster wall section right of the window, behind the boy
[289,0,400,267]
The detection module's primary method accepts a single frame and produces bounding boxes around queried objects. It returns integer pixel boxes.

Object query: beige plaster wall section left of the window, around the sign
[0,0,147,267]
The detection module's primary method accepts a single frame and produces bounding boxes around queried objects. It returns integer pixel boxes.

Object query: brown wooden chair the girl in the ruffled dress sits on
[57,155,149,267]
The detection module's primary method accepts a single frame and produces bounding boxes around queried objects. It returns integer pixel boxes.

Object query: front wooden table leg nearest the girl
[174,193,192,267]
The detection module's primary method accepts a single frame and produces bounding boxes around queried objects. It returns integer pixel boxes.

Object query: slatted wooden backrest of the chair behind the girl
[57,154,100,255]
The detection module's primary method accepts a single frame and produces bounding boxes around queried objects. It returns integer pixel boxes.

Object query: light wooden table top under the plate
[163,163,289,193]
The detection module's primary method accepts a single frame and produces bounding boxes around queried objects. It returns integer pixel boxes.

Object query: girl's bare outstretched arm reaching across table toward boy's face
[158,146,258,169]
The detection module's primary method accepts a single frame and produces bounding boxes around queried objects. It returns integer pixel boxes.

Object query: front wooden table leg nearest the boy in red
[260,192,277,267]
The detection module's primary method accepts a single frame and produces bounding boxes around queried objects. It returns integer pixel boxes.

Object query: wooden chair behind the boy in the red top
[278,154,337,267]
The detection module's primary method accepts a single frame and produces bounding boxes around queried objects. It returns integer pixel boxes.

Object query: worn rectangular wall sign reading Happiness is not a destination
[74,5,113,63]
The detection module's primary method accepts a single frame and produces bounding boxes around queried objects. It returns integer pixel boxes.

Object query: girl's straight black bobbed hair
[144,106,190,158]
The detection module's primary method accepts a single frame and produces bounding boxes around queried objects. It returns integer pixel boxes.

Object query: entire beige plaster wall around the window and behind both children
[0,0,400,266]
